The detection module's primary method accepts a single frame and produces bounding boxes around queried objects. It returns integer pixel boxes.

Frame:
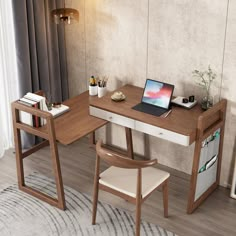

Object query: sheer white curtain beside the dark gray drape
[0,1,19,158]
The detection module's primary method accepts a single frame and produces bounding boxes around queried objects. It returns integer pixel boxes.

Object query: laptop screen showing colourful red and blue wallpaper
[142,80,174,109]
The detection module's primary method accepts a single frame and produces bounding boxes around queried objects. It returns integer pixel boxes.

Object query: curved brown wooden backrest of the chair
[96,139,157,169]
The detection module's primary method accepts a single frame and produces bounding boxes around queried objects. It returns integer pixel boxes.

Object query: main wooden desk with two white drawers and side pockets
[90,85,226,213]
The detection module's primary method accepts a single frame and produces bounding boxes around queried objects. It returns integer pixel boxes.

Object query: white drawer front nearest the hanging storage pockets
[134,121,189,146]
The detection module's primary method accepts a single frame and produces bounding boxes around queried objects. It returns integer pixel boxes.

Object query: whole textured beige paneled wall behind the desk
[66,0,236,188]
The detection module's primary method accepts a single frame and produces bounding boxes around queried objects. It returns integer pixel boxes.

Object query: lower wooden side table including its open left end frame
[12,92,107,209]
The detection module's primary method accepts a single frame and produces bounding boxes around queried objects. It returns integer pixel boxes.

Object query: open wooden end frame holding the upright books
[12,98,65,209]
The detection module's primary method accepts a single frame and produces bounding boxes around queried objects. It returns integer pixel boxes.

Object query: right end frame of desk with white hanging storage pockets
[187,100,226,214]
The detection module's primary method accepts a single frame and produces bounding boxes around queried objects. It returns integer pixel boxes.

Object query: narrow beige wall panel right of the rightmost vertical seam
[221,0,236,185]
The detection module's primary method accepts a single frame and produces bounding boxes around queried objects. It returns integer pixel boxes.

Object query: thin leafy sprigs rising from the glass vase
[193,65,216,97]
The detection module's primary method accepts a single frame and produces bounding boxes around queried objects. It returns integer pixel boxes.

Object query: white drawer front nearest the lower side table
[89,106,134,129]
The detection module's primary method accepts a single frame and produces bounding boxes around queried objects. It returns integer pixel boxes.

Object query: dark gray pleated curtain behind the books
[12,0,68,102]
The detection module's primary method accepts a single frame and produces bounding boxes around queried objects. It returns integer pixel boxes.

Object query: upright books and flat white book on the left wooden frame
[18,92,69,128]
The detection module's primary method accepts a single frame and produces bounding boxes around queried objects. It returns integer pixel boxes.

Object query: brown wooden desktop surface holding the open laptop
[90,85,203,143]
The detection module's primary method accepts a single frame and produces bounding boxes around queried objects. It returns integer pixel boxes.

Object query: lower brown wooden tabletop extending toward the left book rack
[54,91,107,145]
